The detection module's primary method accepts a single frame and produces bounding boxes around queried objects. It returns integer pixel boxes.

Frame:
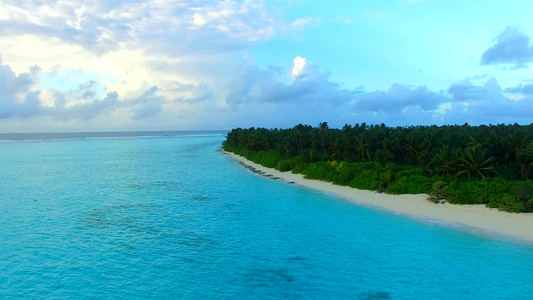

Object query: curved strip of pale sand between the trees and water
[224,152,533,243]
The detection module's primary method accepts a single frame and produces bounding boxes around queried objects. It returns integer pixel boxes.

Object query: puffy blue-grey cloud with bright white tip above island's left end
[214,57,372,127]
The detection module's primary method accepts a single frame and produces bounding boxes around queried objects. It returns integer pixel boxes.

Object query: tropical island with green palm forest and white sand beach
[223,123,533,242]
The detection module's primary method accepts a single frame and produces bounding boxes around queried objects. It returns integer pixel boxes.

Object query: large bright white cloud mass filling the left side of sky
[0,0,322,131]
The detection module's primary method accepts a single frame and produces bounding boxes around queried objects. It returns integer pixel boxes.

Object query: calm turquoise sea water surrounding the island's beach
[0,136,533,299]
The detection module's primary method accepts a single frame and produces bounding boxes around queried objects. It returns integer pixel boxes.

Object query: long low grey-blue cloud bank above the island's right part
[353,78,533,126]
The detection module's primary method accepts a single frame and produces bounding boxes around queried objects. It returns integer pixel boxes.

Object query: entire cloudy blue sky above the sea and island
[0,0,533,132]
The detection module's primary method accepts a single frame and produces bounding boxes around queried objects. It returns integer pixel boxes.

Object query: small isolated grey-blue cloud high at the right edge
[481,27,533,66]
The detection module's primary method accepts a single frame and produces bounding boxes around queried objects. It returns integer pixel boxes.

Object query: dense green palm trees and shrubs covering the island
[223,122,533,212]
